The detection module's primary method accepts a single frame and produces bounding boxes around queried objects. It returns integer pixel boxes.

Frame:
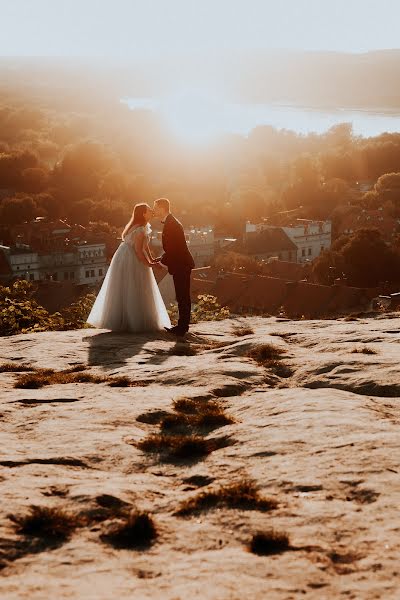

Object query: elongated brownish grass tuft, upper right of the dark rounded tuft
[175,480,278,517]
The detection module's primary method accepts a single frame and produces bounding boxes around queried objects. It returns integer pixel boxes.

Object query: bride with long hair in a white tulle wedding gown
[87,204,171,332]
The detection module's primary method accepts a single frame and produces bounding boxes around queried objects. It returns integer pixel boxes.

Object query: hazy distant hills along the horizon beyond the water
[0,49,400,111]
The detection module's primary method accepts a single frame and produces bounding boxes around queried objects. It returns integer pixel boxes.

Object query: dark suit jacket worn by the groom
[161,214,194,275]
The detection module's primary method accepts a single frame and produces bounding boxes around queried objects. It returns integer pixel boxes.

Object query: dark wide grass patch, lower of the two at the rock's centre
[137,433,232,461]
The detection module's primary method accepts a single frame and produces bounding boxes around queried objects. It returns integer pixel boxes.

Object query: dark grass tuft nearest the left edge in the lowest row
[9,506,82,540]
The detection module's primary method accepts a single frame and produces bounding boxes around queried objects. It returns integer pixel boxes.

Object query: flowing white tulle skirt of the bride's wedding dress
[87,242,171,332]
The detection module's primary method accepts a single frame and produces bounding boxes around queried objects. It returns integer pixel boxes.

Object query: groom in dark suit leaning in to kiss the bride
[154,198,194,336]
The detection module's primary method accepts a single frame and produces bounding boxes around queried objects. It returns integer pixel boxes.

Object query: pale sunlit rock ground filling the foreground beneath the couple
[0,314,400,600]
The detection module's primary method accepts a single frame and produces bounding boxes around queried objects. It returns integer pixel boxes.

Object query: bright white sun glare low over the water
[159,89,227,145]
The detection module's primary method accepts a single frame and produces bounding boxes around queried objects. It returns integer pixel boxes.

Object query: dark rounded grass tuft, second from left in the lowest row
[102,512,158,549]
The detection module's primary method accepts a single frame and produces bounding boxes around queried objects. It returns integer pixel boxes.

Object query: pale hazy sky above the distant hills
[0,0,400,59]
